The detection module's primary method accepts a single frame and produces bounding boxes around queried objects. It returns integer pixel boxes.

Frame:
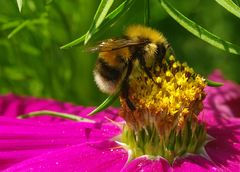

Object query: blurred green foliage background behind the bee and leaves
[0,0,240,105]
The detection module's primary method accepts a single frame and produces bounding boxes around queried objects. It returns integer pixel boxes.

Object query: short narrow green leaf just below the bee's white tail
[87,89,120,116]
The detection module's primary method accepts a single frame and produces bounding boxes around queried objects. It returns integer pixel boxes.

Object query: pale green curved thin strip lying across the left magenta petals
[18,110,94,122]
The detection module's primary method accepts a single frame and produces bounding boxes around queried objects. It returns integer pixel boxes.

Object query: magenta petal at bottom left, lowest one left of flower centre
[2,141,128,172]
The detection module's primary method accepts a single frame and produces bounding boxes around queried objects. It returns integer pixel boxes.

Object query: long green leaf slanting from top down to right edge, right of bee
[159,0,240,54]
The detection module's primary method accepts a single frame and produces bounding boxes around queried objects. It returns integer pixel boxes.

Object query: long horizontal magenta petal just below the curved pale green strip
[0,117,120,170]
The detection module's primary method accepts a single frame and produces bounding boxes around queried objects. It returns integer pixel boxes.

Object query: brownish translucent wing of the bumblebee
[89,39,145,52]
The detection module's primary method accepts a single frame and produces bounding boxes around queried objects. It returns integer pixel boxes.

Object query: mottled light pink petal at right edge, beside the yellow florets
[204,70,240,118]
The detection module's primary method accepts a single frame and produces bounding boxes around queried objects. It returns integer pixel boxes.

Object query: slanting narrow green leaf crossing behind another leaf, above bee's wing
[60,0,135,49]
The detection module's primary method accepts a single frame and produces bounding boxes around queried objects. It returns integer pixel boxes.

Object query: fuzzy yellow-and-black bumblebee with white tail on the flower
[91,25,170,110]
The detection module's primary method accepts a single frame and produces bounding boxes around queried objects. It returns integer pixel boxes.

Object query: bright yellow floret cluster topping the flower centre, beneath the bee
[124,56,206,127]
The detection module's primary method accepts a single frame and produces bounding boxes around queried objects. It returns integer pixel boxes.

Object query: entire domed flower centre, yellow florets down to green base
[120,55,206,162]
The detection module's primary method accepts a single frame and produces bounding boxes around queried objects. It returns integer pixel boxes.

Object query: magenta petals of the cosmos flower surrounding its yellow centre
[0,69,240,172]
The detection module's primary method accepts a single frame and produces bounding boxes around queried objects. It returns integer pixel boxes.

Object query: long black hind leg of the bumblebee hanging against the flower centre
[122,62,136,111]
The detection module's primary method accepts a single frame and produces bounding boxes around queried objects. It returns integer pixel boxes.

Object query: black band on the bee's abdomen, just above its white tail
[96,58,122,81]
